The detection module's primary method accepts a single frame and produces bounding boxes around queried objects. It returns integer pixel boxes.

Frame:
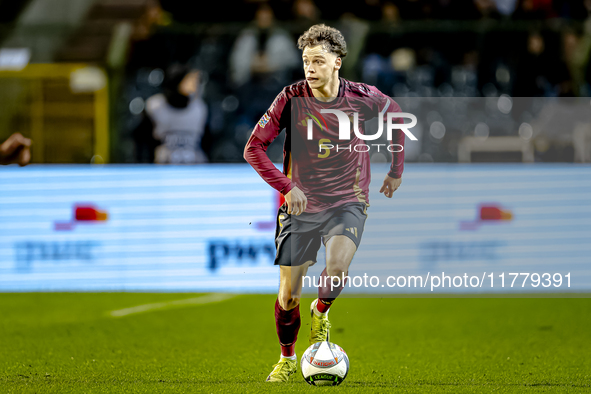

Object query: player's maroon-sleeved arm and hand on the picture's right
[372,87,405,198]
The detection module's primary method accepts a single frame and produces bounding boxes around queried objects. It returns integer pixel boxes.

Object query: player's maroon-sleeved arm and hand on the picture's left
[244,89,308,215]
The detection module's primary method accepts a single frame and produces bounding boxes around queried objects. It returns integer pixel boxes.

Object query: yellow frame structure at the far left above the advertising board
[0,63,109,163]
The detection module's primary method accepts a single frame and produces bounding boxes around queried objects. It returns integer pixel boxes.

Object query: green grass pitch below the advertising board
[0,293,591,393]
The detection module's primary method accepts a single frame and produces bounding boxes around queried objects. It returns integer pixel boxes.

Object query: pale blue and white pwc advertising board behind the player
[0,164,591,293]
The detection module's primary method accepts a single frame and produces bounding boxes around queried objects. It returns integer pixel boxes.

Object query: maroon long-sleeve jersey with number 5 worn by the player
[244,78,405,213]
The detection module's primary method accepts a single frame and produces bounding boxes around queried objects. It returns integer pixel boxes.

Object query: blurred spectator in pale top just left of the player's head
[230,4,300,87]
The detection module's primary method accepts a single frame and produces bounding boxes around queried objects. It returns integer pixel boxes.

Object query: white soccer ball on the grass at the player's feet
[301,341,349,386]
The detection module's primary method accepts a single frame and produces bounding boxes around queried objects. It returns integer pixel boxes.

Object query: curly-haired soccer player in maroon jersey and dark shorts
[244,24,404,382]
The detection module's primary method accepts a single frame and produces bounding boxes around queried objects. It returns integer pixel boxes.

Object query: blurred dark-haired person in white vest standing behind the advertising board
[133,65,208,164]
